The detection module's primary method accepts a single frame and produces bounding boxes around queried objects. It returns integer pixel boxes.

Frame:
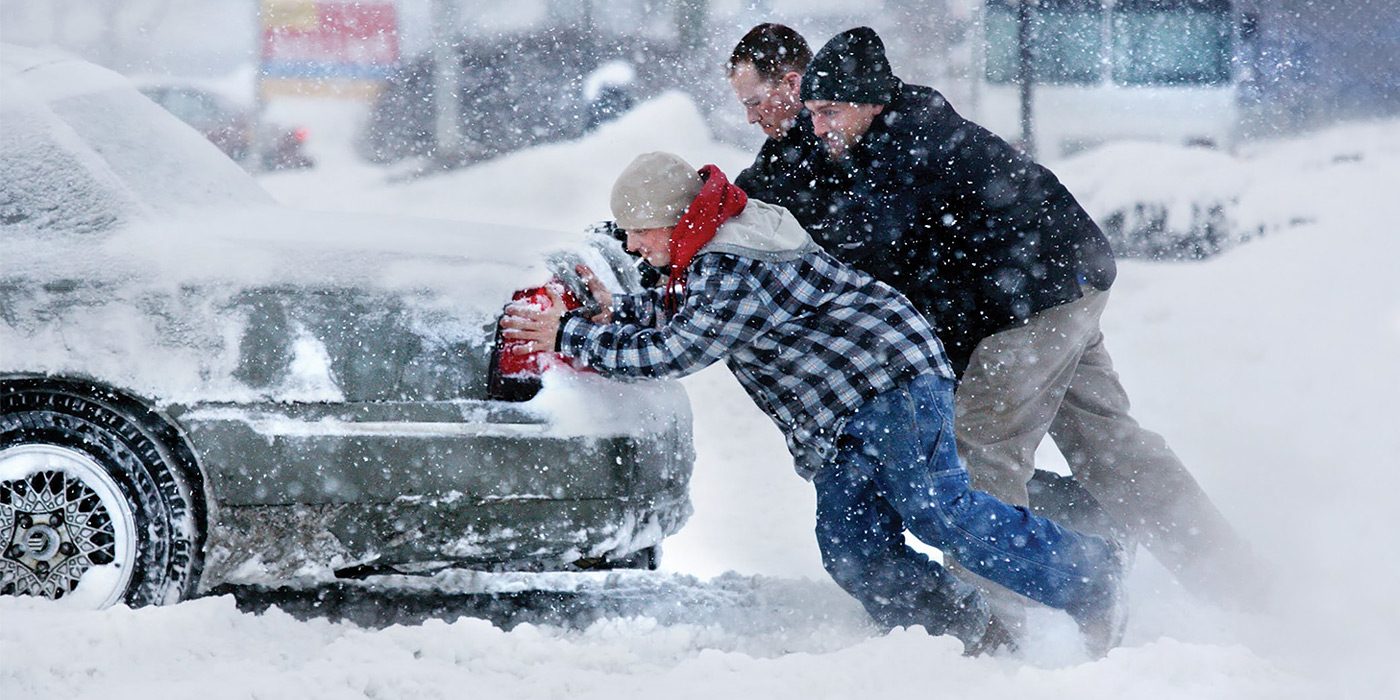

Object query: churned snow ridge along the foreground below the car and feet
[0,596,1316,700]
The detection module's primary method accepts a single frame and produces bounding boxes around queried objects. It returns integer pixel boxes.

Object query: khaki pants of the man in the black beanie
[953,287,1261,624]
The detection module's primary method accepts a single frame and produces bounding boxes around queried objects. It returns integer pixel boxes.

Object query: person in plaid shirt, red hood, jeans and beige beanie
[503,153,1126,655]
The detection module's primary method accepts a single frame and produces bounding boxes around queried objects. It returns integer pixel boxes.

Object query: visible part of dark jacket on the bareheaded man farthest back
[734,109,847,230]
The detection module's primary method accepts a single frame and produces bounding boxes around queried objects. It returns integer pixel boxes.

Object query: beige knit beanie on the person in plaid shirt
[612,151,704,231]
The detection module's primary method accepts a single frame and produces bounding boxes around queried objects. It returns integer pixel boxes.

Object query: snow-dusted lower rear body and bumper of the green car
[172,378,694,588]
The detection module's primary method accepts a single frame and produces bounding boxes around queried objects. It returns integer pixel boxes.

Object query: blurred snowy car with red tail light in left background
[140,84,315,171]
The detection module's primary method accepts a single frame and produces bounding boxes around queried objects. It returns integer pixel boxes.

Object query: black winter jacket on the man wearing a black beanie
[809,85,1116,375]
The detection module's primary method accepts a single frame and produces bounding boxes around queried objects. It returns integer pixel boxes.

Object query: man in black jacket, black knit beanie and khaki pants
[801,27,1257,630]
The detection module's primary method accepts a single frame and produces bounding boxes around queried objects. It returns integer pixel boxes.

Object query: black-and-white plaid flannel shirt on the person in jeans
[559,246,953,479]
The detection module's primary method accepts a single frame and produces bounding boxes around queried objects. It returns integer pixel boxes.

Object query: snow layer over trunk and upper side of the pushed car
[0,200,596,403]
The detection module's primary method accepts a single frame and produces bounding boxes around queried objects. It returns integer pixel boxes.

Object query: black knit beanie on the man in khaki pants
[802,27,900,105]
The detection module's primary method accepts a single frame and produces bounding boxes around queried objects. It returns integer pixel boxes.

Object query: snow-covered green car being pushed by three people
[0,46,694,606]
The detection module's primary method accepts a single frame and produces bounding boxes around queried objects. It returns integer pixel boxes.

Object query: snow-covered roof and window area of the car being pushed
[0,46,272,240]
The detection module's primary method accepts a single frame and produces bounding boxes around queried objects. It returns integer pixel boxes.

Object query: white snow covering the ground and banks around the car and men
[0,95,1400,700]
